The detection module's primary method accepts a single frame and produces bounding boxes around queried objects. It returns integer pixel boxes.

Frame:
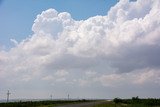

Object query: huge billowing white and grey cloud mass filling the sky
[0,0,160,98]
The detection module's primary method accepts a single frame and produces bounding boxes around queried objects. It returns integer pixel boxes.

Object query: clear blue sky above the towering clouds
[0,0,117,48]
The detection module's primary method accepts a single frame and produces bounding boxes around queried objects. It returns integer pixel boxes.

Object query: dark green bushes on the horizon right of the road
[113,96,160,107]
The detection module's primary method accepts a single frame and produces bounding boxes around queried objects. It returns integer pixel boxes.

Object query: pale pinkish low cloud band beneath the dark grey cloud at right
[97,68,160,87]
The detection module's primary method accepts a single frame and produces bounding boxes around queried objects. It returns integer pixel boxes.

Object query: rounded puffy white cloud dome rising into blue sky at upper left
[32,9,74,38]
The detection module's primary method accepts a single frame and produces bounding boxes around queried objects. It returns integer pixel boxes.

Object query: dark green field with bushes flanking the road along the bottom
[0,97,160,107]
